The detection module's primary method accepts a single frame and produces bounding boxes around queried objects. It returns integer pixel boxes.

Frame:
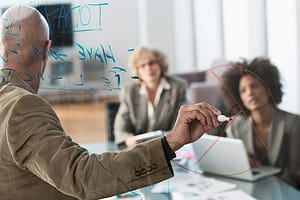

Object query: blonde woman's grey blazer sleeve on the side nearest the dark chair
[114,87,133,144]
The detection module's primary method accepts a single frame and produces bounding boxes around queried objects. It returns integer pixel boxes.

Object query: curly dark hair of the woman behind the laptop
[221,57,283,115]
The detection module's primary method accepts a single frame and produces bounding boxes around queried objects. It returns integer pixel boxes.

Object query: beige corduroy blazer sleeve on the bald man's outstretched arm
[6,95,172,199]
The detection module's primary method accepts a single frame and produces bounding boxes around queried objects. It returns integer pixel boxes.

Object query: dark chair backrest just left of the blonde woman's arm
[105,102,120,142]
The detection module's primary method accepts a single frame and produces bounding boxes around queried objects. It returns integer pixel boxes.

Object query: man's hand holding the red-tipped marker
[167,102,221,151]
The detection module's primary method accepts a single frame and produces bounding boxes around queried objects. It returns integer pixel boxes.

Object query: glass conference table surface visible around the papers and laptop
[81,142,300,200]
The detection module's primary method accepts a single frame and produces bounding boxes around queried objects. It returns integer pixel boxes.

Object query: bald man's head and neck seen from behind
[0,5,51,92]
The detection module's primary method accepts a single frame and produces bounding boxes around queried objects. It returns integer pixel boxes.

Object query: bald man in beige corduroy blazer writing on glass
[0,6,220,200]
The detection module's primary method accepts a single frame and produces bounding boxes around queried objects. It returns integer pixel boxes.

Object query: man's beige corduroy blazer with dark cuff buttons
[0,69,173,200]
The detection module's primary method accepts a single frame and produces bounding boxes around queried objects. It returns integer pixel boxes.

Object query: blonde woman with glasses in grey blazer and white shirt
[114,47,186,147]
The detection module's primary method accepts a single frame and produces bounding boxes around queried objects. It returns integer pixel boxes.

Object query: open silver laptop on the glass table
[192,134,280,181]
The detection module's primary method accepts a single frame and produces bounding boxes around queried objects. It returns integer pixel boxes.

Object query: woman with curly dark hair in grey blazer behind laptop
[222,57,300,189]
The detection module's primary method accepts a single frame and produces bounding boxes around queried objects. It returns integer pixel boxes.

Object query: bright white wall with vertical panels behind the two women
[1,0,300,113]
